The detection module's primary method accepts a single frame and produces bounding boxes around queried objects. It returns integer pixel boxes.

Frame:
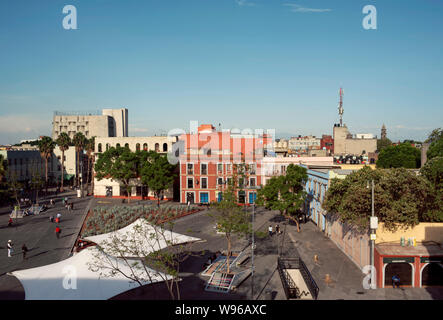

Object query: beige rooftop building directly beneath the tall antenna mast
[334,125,377,156]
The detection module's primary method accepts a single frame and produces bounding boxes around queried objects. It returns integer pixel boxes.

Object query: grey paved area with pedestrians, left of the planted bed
[0,191,92,300]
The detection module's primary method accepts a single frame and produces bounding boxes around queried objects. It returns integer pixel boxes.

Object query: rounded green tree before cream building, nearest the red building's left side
[139,151,176,206]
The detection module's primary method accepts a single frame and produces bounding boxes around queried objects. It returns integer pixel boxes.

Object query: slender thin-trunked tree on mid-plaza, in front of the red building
[212,164,251,273]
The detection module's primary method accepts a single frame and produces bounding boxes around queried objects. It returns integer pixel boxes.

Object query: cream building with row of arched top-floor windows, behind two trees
[94,136,177,200]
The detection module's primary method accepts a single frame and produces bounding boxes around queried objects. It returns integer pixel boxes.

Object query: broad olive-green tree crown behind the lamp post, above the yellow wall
[323,167,432,231]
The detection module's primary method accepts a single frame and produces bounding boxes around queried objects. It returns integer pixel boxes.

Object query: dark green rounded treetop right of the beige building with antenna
[377,143,421,169]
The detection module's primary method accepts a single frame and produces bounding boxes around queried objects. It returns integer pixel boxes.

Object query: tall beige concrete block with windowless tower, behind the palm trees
[52,108,128,140]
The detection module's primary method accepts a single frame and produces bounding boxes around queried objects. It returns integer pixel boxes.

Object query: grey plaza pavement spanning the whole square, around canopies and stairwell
[0,198,443,300]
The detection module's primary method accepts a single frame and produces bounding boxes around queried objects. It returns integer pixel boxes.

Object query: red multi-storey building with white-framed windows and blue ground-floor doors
[179,124,271,204]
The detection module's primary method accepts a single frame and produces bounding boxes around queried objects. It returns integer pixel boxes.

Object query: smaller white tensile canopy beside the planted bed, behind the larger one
[84,218,201,257]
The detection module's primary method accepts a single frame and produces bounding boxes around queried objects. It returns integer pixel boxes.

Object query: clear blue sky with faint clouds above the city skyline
[0,0,443,144]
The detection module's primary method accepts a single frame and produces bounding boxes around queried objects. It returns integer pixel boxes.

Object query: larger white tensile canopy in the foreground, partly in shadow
[11,247,172,300]
